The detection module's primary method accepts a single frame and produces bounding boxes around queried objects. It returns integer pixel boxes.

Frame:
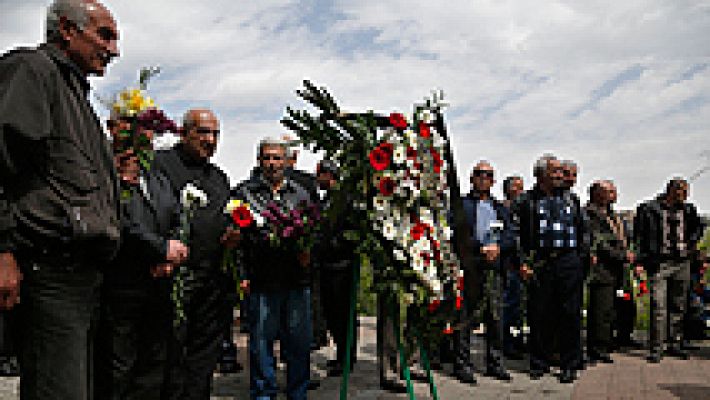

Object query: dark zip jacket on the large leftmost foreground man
[0,44,120,265]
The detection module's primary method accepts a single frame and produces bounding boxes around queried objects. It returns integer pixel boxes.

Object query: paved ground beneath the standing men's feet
[0,318,710,400]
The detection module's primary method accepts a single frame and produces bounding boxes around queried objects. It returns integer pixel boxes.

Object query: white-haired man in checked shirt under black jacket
[513,155,589,383]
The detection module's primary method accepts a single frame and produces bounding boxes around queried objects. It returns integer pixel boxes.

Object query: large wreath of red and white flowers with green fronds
[282,81,470,344]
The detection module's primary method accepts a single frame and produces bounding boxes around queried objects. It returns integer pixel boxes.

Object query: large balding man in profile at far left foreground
[0,0,120,400]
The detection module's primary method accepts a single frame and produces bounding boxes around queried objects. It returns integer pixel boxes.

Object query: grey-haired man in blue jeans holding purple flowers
[232,138,319,400]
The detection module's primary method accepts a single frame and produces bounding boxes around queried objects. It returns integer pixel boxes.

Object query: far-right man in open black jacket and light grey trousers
[634,178,703,363]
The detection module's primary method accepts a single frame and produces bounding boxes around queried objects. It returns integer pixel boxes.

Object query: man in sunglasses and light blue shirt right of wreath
[454,161,514,383]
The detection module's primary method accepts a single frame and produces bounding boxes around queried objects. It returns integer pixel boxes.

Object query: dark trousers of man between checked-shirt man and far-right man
[587,282,616,356]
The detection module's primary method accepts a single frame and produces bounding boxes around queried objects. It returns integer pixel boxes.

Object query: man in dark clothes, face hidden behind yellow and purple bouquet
[95,116,188,400]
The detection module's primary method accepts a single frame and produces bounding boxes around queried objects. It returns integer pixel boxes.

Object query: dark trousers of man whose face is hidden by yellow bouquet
[96,276,172,400]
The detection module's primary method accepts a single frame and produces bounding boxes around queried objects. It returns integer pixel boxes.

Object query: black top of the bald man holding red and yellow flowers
[152,144,229,274]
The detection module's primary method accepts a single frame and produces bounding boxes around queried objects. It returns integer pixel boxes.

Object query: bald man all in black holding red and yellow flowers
[154,109,236,400]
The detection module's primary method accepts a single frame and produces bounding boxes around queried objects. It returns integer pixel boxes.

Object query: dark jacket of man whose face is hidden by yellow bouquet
[107,170,180,283]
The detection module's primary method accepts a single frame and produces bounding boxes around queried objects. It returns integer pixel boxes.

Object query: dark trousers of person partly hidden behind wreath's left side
[321,268,357,366]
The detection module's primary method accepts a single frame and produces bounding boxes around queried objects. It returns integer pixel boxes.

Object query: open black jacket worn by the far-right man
[634,196,704,270]
